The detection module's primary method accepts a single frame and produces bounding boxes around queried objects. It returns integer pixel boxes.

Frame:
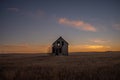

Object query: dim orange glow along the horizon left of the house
[0,45,49,53]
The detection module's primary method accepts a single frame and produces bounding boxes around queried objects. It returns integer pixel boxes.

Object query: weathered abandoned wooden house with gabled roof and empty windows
[52,37,69,56]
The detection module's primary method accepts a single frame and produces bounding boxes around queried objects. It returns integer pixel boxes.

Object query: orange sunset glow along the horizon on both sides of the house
[0,45,120,53]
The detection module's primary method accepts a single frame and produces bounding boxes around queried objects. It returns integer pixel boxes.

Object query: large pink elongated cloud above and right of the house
[58,18,96,32]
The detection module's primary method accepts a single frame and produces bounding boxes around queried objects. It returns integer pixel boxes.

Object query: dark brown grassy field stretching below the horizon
[0,52,120,80]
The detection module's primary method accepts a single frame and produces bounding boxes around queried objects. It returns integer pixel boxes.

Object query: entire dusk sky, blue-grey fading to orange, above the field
[0,0,120,53]
